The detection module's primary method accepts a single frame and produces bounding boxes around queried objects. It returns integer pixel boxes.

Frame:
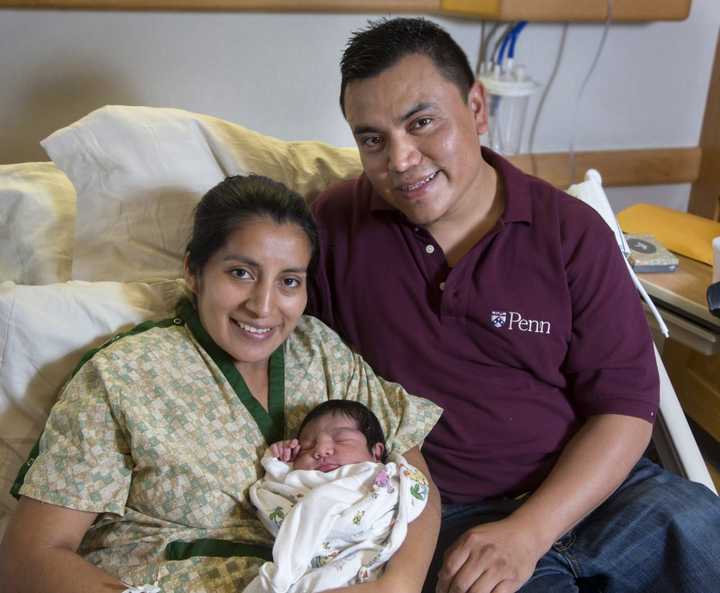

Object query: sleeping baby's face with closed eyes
[293,414,383,472]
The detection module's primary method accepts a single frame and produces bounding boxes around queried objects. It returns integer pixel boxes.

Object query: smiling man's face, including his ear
[345,54,487,230]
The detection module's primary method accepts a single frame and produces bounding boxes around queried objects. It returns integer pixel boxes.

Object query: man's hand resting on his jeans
[436,518,547,593]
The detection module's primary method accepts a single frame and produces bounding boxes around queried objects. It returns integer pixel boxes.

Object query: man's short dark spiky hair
[340,18,475,115]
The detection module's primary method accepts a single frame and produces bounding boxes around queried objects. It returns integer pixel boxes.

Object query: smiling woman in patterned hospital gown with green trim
[0,176,439,593]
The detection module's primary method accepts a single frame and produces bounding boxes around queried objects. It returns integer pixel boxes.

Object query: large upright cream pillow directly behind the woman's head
[42,106,362,281]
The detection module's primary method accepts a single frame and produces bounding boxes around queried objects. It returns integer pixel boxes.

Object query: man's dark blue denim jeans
[423,459,720,593]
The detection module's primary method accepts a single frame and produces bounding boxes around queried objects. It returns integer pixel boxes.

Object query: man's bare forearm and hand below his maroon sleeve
[438,414,652,593]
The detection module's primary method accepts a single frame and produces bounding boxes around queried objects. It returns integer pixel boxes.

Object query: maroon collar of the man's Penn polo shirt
[368,146,532,223]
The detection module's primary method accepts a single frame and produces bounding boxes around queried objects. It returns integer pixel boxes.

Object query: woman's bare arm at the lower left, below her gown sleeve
[0,497,127,593]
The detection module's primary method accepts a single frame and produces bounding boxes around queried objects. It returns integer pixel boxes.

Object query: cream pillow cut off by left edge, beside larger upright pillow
[0,163,75,284]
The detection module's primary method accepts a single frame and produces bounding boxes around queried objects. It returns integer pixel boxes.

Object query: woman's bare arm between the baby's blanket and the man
[327,447,440,593]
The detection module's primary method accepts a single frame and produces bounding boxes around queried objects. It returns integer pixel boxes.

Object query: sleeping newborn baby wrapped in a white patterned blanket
[245,400,428,593]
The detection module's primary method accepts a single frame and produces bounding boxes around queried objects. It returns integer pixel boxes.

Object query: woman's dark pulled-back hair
[185,175,318,275]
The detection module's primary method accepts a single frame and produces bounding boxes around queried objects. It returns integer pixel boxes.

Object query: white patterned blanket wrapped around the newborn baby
[244,451,428,593]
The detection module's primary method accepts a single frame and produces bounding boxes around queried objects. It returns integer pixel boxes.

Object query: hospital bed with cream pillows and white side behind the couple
[0,107,714,532]
